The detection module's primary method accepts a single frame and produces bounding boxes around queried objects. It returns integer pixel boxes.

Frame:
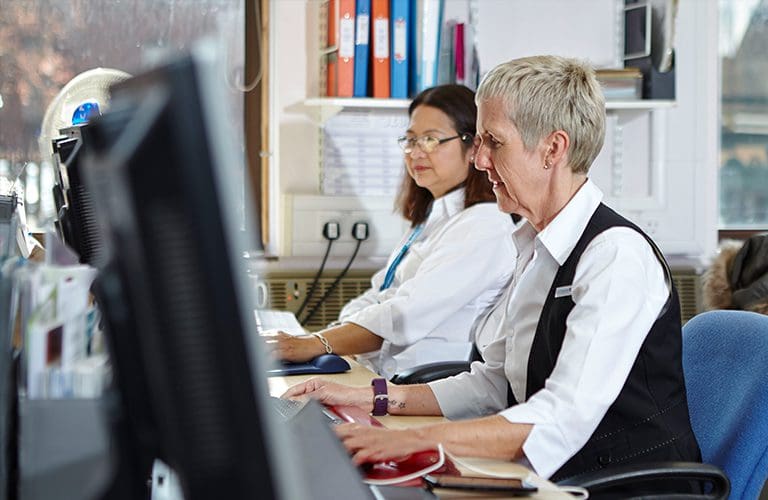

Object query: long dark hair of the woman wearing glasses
[395,85,496,226]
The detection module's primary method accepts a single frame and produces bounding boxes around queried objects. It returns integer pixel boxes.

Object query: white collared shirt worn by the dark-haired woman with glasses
[339,189,516,378]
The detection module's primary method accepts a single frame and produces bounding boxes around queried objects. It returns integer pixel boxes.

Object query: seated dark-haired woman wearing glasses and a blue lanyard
[268,85,515,379]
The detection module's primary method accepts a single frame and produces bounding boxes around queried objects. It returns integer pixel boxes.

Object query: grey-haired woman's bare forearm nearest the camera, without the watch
[414,415,533,460]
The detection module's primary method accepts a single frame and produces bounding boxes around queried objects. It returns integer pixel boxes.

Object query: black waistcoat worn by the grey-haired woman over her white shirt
[526,203,701,481]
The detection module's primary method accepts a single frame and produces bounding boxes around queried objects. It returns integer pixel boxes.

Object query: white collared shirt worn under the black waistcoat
[430,181,669,477]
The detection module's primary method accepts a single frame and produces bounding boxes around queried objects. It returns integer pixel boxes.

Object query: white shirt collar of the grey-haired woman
[514,179,603,266]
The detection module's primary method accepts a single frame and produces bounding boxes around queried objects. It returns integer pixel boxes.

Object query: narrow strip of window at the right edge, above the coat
[719,0,768,231]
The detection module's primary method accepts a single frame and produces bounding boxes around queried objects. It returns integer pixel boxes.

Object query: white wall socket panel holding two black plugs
[287,195,408,257]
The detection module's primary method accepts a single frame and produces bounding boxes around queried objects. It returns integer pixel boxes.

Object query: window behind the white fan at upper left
[0,0,244,228]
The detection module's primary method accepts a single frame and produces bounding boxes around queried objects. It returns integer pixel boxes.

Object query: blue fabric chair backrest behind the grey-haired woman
[683,311,768,499]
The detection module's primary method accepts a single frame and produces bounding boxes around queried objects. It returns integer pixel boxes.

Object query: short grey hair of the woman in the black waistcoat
[475,56,605,173]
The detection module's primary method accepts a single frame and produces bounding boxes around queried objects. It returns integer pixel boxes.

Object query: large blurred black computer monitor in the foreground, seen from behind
[81,46,312,500]
